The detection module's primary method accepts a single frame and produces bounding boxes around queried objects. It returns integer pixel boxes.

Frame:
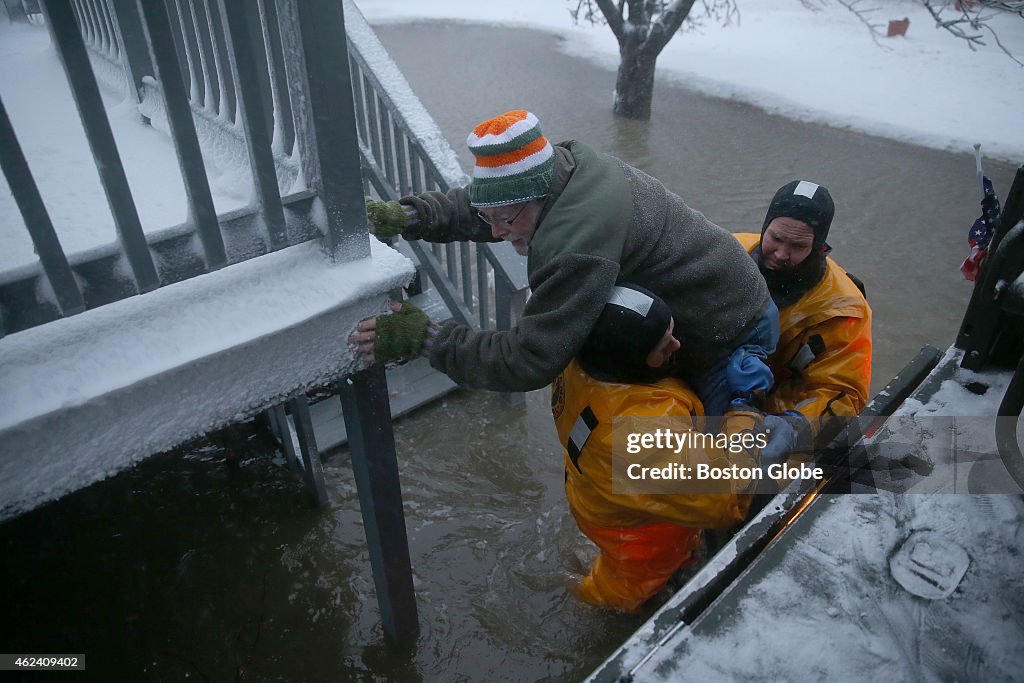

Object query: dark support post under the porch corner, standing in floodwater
[339,365,419,642]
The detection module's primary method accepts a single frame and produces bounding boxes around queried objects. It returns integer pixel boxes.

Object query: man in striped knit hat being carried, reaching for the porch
[351,110,778,414]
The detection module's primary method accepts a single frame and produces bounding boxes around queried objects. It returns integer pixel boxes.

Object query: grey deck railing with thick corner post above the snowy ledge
[0,0,370,334]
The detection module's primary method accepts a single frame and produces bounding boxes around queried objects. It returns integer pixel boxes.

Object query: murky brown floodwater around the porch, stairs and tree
[0,24,1013,681]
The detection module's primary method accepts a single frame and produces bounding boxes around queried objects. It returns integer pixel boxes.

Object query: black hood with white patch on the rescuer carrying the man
[577,284,672,382]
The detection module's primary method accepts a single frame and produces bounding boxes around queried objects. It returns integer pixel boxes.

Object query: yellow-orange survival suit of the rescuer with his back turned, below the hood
[552,360,761,611]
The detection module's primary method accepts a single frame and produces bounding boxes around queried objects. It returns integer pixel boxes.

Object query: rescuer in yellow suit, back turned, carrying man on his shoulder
[552,285,771,611]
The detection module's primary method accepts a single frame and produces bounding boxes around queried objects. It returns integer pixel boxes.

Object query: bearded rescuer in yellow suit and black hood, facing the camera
[736,180,871,452]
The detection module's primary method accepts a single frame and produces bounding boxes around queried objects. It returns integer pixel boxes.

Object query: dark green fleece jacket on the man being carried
[400,141,769,391]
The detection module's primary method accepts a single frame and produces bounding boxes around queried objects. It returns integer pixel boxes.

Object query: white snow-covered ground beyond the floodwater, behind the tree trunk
[357,0,1024,163]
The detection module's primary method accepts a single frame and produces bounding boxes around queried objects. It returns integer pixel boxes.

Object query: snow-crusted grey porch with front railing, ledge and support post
[0,0,418,640]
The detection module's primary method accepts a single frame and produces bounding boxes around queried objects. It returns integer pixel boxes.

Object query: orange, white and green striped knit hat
[466,110,555,206]
